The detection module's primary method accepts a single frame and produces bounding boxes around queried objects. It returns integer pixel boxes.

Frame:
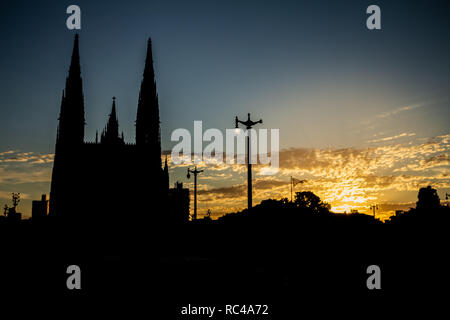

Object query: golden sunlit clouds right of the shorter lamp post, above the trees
[170,135,450,218]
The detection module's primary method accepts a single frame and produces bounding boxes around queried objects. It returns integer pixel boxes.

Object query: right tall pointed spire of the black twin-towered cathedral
[136,39,161,168]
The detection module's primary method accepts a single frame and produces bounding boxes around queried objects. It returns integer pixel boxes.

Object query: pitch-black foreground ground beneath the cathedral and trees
[0,211,450,319]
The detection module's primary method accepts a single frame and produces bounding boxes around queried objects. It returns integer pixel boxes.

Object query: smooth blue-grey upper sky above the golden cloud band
[0,0,450,152]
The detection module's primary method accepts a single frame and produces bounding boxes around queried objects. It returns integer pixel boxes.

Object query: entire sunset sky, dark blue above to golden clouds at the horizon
[0,0,450,218]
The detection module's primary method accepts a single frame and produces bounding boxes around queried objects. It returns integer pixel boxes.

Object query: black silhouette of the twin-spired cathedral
[49,34,174,224]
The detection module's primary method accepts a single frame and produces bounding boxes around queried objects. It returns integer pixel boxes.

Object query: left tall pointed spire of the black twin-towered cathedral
[57,34,85,145]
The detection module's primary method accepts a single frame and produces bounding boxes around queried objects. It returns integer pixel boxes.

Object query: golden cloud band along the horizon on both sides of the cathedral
[0,134,450,220]
